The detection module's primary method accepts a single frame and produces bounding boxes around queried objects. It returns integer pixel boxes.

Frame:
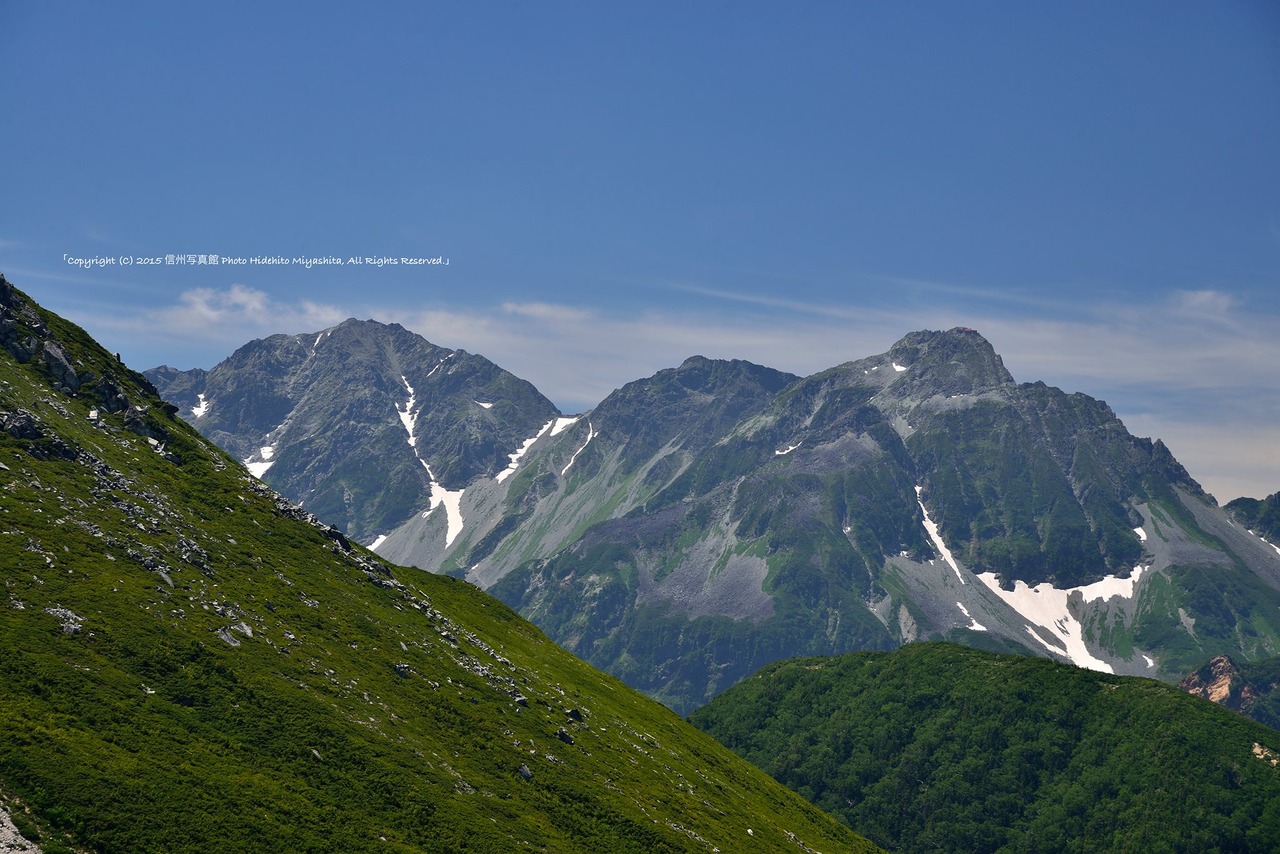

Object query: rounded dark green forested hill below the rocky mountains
[691,643,1280,851]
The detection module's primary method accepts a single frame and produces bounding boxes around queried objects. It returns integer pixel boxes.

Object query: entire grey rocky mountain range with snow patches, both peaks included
[147,320,1280,713]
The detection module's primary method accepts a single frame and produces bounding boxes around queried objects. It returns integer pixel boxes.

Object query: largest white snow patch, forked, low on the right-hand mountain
[978,566,1146,673]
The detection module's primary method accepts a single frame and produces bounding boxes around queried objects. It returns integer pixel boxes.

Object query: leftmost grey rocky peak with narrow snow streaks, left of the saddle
[147,319,559,542]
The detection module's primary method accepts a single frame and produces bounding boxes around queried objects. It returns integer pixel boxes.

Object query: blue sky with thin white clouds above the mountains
[0,1,1280,501]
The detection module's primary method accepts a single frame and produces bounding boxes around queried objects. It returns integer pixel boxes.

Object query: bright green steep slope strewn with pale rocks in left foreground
[0,277,870,853]
